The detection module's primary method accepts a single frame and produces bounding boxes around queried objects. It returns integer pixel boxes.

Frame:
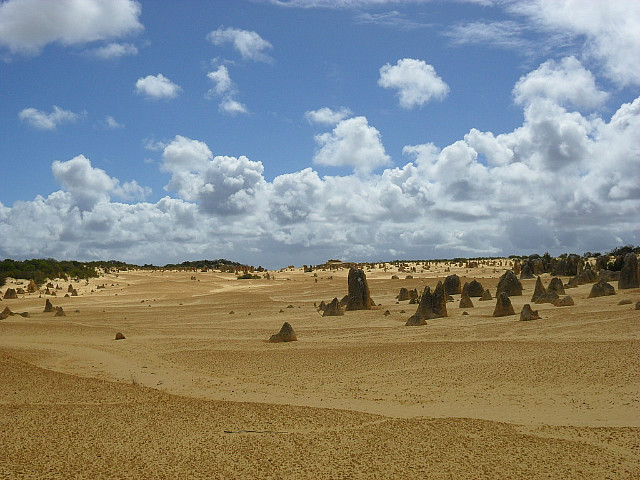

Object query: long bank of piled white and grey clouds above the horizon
[0,57,640,267]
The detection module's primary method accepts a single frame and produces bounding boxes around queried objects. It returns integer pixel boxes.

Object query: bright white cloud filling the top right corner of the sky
[507,0,640,86]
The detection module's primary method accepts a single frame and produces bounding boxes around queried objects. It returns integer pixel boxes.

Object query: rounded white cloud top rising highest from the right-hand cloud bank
[513,57,608,109]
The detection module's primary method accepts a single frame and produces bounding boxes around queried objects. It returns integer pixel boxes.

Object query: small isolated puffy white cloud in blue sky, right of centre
[378,58,449,109]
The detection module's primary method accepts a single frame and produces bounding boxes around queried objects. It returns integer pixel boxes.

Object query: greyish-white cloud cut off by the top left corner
[0,0,143,55]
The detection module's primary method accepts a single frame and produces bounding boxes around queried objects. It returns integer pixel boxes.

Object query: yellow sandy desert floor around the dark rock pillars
[0,265,640,479]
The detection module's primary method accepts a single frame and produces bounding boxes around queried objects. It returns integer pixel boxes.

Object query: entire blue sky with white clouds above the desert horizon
[0,0,640,268]
